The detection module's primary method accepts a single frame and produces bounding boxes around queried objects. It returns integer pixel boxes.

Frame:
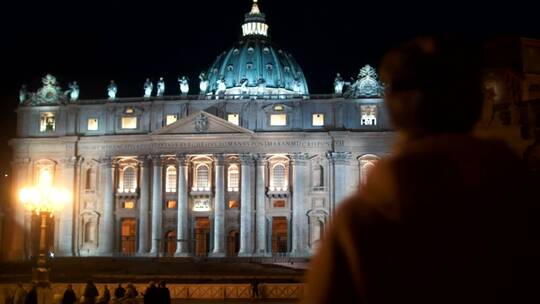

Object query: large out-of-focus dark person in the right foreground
[304,36,540,304]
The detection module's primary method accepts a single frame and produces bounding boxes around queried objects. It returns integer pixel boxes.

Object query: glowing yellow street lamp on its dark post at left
[19,170,71,287]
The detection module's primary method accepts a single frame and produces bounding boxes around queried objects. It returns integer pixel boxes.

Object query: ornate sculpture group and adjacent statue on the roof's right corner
[334,64,384,98]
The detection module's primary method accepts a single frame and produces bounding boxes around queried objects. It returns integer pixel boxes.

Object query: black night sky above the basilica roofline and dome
[0,0,540,172]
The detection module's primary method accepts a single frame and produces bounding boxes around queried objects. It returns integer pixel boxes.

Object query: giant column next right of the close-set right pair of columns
[291,153,309,256]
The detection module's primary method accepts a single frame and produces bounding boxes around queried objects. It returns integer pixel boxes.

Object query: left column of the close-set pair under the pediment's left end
[139,156,150,255]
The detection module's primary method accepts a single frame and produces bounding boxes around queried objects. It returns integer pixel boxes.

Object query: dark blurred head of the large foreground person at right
[379,36,483,137]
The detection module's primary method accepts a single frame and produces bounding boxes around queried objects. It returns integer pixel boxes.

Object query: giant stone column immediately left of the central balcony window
[174,154,189,257]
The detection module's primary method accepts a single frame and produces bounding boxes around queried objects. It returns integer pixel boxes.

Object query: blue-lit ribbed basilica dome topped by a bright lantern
[206,0,308,95]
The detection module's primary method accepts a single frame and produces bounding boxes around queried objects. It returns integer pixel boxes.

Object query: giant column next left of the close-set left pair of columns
[98,158,116,256]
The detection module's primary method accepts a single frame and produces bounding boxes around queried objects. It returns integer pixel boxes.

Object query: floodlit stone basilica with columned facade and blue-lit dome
[4,1,394,260]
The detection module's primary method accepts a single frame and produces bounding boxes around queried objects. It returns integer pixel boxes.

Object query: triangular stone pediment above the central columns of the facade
[153,111,253,134]
